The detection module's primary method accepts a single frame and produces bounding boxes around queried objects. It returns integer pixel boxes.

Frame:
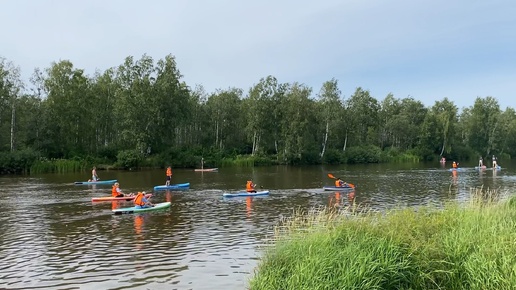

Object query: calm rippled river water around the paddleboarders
[0,163,516,290]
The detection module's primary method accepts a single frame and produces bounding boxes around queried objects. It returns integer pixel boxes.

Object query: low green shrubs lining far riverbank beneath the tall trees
[0,146,432,174]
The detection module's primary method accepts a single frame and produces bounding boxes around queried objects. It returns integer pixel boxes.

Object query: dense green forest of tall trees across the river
[0,55,516,172]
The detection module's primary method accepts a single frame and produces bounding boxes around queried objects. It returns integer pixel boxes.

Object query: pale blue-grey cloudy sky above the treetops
[0,0,516,109]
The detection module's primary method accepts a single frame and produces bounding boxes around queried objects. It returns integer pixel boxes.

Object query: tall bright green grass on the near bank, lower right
[250,189,516,290]
